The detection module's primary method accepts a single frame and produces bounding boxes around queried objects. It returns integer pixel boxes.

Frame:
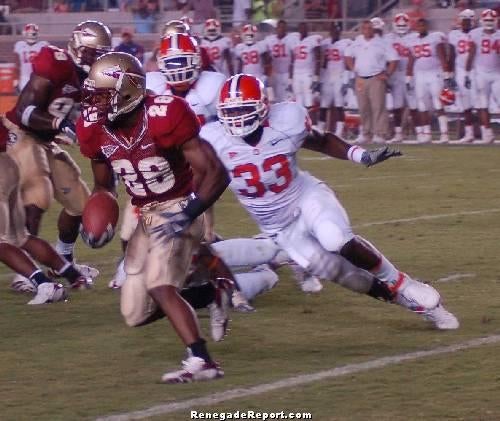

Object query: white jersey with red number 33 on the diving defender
[200,102,321,234]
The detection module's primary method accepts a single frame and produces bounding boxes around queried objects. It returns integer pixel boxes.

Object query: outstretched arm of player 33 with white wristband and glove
[302,130,402,167]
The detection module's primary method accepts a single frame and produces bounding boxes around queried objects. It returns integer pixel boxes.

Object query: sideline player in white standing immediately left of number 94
[448,9,475,144]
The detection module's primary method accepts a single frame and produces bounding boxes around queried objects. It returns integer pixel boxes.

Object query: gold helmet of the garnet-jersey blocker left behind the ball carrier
[68,20,111,73]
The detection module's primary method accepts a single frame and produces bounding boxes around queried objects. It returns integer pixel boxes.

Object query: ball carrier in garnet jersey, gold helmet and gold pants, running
[77,52,228,383]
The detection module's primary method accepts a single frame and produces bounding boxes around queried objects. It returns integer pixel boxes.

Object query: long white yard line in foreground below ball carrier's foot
[97,335,500,421]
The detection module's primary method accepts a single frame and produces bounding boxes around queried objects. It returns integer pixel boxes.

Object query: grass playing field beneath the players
[0,147,500,421]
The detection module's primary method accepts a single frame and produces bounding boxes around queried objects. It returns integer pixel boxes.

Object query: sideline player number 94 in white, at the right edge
[469,9,500,145]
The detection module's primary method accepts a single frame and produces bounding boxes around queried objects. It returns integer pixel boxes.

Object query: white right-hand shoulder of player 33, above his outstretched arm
[269,102,310,136]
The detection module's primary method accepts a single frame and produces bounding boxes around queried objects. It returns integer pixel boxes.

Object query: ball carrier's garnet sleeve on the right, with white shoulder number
[149,96,200,149]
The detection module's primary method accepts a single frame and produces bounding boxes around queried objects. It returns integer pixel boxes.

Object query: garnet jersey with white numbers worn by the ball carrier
[76,95,200,206]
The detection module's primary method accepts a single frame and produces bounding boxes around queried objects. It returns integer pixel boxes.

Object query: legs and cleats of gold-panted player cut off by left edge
[0,122,89,304]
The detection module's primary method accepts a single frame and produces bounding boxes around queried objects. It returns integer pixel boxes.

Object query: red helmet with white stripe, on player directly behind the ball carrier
[157,34,201,86]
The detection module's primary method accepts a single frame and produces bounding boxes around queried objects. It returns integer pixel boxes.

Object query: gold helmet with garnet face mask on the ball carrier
[82,52,146,122]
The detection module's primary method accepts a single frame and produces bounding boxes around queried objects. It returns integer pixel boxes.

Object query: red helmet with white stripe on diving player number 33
[217,74,269,136]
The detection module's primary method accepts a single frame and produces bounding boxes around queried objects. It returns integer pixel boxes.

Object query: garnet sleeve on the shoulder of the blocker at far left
[31,46,74,85]
